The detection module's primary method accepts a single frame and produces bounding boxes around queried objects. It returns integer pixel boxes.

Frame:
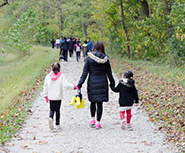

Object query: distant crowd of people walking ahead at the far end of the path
[51,37,93,62]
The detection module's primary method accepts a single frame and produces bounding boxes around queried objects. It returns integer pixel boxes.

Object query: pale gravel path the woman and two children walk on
[3,54,177,153]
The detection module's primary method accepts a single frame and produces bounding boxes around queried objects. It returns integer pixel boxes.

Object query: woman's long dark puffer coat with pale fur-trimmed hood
[77,51,115,102]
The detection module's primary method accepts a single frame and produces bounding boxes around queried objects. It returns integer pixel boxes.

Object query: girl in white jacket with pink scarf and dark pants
[43,63,78,130]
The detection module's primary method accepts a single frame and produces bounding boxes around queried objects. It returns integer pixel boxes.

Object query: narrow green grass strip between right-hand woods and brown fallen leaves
[110,54,185,89]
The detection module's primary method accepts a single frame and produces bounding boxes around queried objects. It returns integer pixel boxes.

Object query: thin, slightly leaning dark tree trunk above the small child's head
[120,0,130,58]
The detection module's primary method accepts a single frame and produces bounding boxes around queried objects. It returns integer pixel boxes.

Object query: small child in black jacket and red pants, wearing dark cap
[111,71,139,130]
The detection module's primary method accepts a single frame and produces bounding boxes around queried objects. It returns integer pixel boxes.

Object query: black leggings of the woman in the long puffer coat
[90,102,103,122]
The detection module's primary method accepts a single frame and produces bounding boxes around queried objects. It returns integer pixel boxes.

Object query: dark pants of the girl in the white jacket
[49,100,61,125]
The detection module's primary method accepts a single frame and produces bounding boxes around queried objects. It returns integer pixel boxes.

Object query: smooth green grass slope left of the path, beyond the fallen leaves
[0,46,58,112]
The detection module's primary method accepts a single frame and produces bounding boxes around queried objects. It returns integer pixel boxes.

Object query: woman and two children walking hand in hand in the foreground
[43,41,139,130]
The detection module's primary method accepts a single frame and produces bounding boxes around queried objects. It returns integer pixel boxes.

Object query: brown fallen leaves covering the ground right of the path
[111,58,185,152]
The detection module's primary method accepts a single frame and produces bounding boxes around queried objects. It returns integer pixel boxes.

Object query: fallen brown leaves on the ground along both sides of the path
[0,50,185,152]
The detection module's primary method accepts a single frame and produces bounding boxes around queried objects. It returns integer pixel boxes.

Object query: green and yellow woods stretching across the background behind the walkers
[0,0,185,66]
